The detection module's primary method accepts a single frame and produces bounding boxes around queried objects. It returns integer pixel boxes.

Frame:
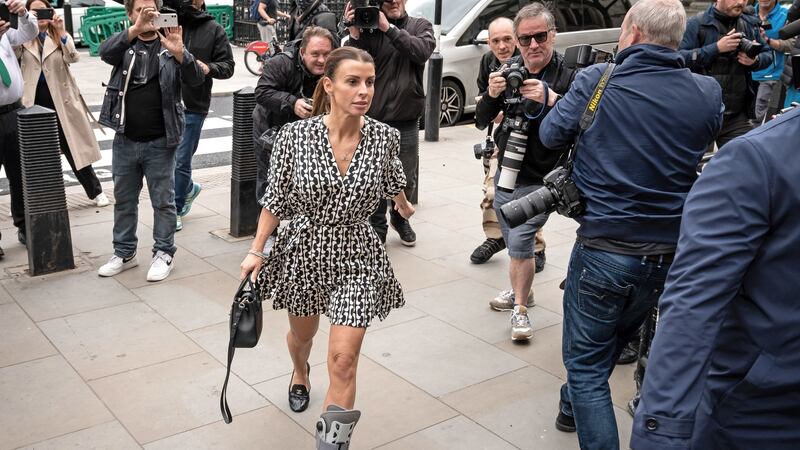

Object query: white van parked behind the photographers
[406,0,636,126]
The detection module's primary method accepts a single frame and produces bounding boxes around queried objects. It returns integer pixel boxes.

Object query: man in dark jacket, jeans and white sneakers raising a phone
[98,0,205,281]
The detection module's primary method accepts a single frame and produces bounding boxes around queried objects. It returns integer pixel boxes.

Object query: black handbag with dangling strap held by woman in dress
[219,274,263,423]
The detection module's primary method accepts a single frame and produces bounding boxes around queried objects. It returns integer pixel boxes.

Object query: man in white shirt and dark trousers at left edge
[0,0,39,258]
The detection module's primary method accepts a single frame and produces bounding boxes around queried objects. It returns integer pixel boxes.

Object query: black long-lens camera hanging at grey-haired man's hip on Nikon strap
[500,166,585,228]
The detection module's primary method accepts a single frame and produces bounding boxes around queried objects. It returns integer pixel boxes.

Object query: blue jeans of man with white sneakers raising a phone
[111,134,176,258]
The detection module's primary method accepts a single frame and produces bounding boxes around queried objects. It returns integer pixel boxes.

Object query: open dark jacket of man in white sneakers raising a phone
[99,30,205,146]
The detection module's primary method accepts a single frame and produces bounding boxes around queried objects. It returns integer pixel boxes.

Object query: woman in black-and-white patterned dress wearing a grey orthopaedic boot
[241,47,414,449]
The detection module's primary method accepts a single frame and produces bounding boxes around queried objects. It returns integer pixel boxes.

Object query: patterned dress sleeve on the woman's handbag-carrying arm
[260,126,296,220]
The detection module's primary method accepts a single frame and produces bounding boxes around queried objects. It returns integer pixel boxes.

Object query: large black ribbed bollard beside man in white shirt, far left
[17,106,75,276]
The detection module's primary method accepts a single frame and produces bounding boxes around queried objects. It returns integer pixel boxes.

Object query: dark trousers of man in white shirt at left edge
[0,105,25,236]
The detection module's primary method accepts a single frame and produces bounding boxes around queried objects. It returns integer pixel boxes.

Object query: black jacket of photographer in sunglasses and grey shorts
[475,51,575,186]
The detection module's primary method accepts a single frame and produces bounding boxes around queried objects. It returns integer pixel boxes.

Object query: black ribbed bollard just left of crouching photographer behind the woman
[230,86,261,237]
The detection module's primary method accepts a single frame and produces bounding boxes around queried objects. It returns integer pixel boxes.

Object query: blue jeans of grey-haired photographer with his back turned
[561,242,670,450]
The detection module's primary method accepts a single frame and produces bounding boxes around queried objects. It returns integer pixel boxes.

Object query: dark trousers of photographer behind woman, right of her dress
[368,120,419,242]
